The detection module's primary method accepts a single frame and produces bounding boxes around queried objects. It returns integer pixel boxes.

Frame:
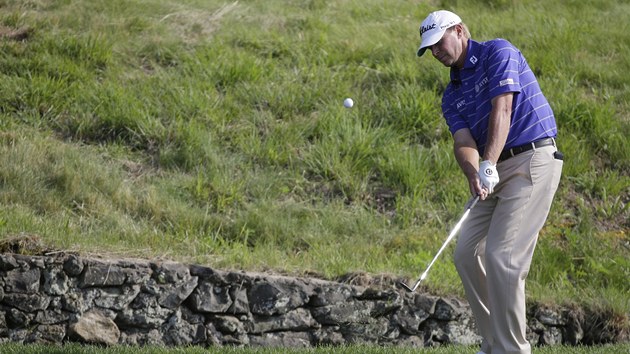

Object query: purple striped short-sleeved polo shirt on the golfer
[442,39,557,155]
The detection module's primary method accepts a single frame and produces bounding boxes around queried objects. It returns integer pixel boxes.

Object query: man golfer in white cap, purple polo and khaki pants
[417,11,563,354]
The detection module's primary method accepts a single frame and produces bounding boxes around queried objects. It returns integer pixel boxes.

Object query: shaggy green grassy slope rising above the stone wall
[0,0,630,334]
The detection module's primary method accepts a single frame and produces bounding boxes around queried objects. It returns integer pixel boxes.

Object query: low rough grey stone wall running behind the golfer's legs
[0,254,624,347]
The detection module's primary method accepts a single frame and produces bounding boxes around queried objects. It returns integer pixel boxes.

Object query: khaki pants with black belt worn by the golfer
[455,146,563,354]
